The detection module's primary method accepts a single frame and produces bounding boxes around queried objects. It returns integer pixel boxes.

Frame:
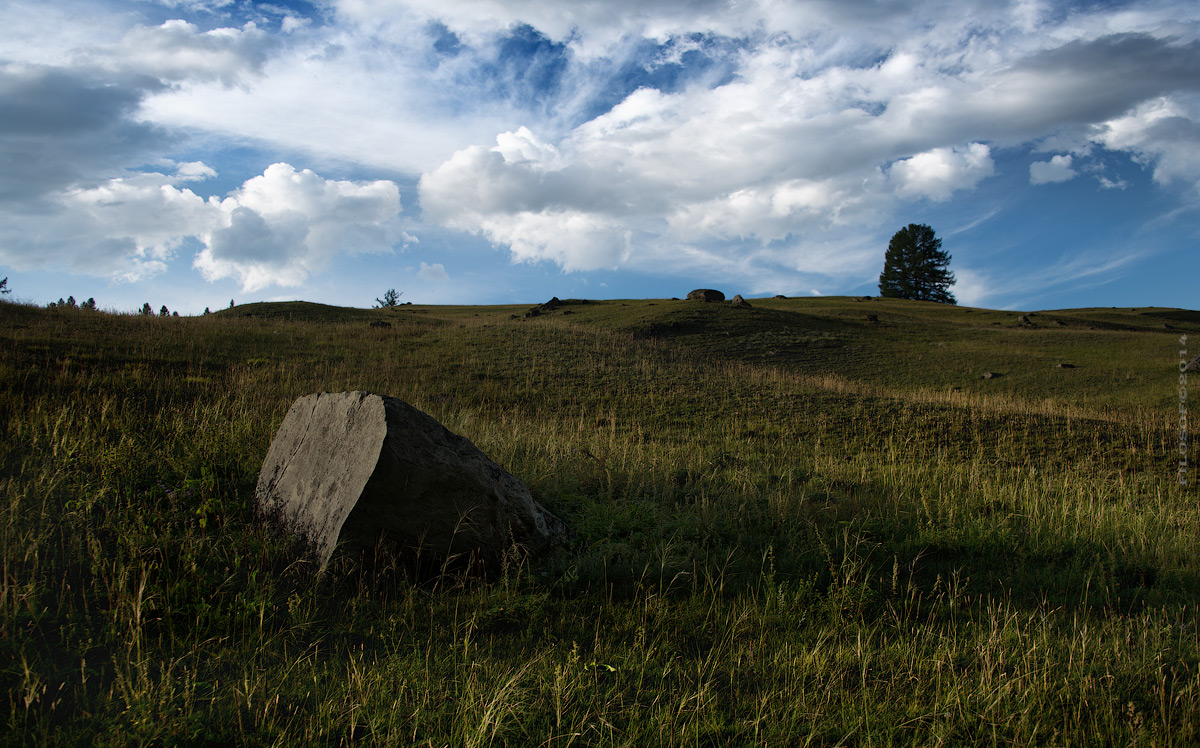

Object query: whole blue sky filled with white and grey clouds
[0,0,1200,315]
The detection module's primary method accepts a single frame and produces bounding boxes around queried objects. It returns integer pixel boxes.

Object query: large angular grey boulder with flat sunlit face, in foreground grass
[256,391,566,570]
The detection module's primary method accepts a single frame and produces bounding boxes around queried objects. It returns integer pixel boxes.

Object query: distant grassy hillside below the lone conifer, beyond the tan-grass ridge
[217,297,1200,407]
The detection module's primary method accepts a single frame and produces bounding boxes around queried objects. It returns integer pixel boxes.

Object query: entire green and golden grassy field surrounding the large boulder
[0,298,1200,747]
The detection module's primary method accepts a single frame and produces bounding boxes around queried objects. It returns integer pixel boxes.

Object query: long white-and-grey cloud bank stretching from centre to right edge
[420,26,1200,286]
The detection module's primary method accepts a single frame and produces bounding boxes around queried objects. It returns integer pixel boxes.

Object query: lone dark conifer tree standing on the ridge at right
[880,223,955,304]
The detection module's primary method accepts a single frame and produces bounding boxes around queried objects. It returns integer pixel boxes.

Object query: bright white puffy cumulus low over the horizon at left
[24,162,412,292]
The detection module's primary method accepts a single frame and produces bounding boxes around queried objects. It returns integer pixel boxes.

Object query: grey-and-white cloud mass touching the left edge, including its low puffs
[0,20,403,291]
